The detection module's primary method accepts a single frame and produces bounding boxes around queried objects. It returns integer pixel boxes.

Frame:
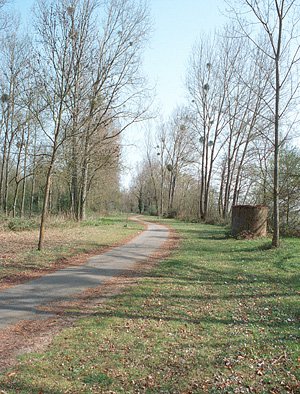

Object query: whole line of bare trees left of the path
[0,0,150,249]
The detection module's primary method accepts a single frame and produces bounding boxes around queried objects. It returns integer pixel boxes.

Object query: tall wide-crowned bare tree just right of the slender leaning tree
[61,0,149,220]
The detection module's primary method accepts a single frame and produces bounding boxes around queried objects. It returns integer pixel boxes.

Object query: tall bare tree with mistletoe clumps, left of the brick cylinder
[187,36,234,220]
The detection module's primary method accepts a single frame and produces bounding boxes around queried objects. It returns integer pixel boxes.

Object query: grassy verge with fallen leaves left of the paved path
[0,216,143,287]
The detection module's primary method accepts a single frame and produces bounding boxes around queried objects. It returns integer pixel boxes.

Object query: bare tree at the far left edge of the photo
[0,32,29,216]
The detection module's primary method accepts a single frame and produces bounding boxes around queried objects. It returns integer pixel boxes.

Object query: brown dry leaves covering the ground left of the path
[0,223,143,291]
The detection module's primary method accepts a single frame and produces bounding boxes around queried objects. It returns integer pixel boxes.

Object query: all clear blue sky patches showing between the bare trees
[10,0,226,187]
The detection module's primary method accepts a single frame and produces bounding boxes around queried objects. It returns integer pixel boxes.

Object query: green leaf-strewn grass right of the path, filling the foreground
[0,221,300,394]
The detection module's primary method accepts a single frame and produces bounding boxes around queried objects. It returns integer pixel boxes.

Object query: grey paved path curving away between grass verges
[0,219,169,329]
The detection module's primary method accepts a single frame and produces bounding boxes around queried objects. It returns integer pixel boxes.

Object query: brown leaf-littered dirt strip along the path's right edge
[0,229,180,373]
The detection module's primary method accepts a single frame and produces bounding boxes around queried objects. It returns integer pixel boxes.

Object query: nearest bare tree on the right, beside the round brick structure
[227,0,300,247]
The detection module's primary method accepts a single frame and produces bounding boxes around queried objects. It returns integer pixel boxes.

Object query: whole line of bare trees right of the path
[127,0,300,247]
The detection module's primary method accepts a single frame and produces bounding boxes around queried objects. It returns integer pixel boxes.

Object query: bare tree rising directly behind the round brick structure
[219,38,270,218]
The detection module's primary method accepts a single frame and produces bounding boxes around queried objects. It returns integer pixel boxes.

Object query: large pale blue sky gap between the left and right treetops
[144,0,225,115]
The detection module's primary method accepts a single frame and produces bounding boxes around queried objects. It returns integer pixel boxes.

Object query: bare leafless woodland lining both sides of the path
[0,0,300,249]
